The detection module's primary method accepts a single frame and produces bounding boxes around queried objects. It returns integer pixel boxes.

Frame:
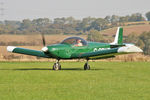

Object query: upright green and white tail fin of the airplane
[111,27,123,45]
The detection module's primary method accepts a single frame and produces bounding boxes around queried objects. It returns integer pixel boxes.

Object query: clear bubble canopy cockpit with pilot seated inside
[61,37,87,46]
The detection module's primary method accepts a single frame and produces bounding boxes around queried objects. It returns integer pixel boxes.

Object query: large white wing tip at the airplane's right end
[118,45,143,53]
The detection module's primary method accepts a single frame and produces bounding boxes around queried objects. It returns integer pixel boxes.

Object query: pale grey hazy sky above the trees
[0,0,150,20]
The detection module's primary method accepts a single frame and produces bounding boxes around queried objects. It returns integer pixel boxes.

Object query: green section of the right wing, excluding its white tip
[72,48,118,59]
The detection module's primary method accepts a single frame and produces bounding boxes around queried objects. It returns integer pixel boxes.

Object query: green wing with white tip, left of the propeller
[7,46,50,58]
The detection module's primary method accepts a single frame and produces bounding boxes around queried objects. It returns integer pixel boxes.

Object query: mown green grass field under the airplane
[0,62,150,100]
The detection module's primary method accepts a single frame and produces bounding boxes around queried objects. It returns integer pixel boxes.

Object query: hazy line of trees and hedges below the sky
[0,12,150,35]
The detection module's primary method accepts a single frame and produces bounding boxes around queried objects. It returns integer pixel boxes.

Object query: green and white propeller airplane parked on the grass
[7,27,143,70]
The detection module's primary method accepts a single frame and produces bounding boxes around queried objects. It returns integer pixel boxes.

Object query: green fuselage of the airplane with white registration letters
[47,42,114,59]
